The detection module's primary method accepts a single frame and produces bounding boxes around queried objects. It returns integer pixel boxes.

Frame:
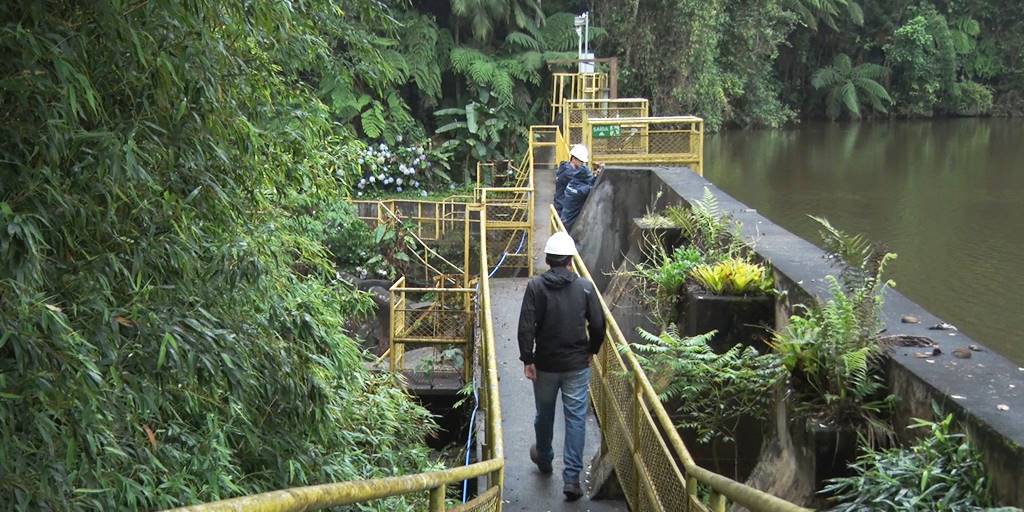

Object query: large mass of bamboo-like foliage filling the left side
[0,1,444,510]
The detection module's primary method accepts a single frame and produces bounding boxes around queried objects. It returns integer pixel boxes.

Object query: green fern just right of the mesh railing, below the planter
[632,326,785,452]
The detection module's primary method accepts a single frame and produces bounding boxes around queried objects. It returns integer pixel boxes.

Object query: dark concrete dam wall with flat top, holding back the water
[572,167,1024,507]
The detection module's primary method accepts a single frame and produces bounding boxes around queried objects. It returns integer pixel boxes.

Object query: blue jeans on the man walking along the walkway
[534,368,590,483]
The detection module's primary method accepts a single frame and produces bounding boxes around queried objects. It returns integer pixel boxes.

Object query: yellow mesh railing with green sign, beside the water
[581,116,703,175]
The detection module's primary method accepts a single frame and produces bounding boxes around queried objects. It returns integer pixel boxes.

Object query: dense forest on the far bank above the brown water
[593,0,1024,130]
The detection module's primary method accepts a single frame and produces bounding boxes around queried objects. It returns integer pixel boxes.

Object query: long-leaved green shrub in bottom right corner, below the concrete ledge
[822,415,992,512]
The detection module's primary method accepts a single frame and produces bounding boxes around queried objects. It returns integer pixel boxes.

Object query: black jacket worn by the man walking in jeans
[519,267,604,372]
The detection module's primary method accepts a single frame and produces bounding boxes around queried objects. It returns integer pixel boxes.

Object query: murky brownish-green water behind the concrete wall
[705,119,1024,364]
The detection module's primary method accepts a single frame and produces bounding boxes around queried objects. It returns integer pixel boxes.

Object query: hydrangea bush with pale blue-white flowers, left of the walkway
[354,136,452,197]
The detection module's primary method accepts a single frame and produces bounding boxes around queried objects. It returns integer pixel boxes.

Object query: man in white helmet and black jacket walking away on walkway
[519,232,604,501]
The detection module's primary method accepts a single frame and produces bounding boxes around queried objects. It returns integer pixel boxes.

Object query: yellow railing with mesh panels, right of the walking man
[549,206,809,512]
